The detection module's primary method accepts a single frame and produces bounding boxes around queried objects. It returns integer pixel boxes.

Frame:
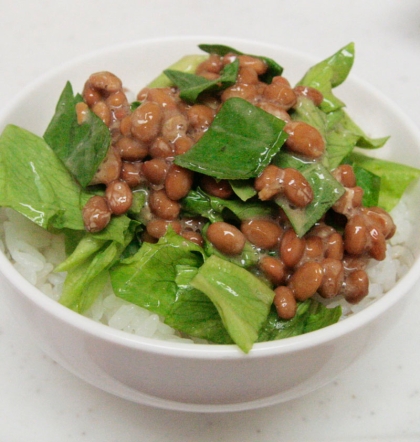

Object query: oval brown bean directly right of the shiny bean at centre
[241,219,283,250]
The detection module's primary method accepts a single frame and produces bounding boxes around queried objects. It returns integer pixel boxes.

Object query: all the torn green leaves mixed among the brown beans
[0,43,420,353]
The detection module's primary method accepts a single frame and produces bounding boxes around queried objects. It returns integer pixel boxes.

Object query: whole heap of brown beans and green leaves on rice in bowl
[0,39,419,352]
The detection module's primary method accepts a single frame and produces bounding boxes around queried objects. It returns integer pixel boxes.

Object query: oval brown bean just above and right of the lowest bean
[288,261,324,301]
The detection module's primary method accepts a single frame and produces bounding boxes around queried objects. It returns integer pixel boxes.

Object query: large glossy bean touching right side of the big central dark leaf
[284,121,325,158]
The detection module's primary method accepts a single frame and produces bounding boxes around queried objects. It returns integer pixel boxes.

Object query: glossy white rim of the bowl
[0,35,420,359]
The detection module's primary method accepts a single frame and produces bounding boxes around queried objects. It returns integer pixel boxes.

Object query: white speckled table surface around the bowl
[0,0,420,442]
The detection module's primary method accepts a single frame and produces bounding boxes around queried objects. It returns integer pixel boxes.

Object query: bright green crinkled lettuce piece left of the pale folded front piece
[110,228,204,316]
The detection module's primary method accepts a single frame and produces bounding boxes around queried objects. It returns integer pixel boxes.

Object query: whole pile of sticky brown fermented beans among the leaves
[76,54,395,319]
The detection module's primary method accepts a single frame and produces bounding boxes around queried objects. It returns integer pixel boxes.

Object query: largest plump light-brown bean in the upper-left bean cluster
[131,101,163,143]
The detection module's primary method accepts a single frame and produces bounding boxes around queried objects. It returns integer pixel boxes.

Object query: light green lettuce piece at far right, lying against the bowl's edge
[346,152,420,212]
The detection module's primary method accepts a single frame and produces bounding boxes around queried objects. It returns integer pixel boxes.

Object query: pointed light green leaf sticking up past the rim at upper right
[297,43,354,112]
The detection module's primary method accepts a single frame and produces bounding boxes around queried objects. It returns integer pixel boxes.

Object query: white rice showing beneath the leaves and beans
[0,183,420,342]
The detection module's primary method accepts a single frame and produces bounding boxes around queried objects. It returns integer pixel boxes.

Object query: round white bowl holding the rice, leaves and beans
[0,37,420,412]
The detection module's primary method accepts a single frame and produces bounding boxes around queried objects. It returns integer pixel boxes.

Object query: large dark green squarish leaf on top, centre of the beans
[174,98,287,179]
